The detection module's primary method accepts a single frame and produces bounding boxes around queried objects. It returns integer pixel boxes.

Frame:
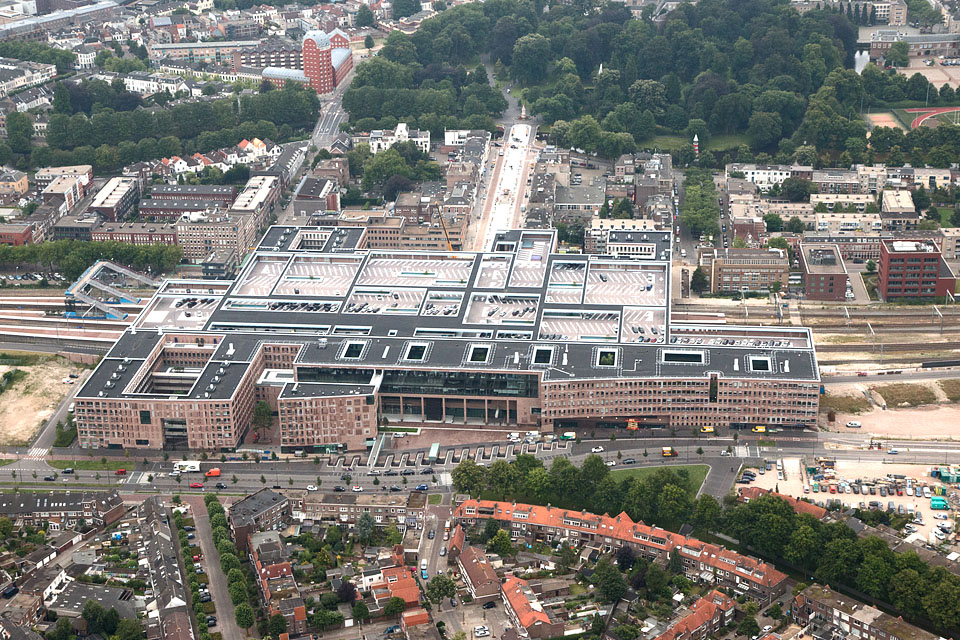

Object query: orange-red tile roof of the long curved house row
[454,499,787,587]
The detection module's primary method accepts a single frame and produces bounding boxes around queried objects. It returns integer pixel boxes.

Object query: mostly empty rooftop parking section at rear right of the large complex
[584,263,667,307]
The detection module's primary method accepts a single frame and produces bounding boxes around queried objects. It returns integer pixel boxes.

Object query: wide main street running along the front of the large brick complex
[0,430,960,497]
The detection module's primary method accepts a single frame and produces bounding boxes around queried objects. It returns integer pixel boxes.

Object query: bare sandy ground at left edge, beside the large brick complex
[0,359,80,445]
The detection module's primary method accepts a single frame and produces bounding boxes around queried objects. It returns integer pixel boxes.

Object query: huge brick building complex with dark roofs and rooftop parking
[75,228,819,451]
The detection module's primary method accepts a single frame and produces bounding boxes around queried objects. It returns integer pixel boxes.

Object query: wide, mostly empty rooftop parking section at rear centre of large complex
[357,254,474,287]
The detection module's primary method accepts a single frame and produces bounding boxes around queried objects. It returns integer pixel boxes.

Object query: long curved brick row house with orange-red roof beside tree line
[454,500,787,602]
